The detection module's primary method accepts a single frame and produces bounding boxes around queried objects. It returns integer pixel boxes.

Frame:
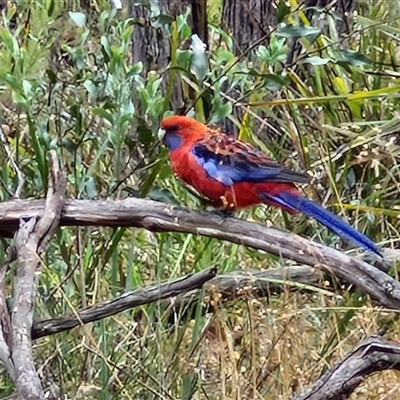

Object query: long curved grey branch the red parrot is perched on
[0,198,400,309]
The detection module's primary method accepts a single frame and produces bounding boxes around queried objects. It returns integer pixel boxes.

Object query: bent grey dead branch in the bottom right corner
[292,336,400,400]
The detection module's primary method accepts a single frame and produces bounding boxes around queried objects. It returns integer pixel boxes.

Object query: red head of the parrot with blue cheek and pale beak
[159,115,207,151]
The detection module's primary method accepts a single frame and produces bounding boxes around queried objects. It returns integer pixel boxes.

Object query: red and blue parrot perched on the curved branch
[159,115,381,256]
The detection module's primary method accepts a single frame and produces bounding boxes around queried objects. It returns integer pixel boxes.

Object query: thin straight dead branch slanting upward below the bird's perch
[32,268,217,339]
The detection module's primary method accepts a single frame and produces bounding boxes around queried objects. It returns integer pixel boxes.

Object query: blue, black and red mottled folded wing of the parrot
[191,130,311,186]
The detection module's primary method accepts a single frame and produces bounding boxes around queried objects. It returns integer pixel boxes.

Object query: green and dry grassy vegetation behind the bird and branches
[0,0,400,400]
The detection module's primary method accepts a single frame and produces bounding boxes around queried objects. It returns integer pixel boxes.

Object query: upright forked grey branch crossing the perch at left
[11,152,65,400]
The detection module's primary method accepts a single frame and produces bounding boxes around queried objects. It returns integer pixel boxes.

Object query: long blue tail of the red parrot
[261,192,381,256]
